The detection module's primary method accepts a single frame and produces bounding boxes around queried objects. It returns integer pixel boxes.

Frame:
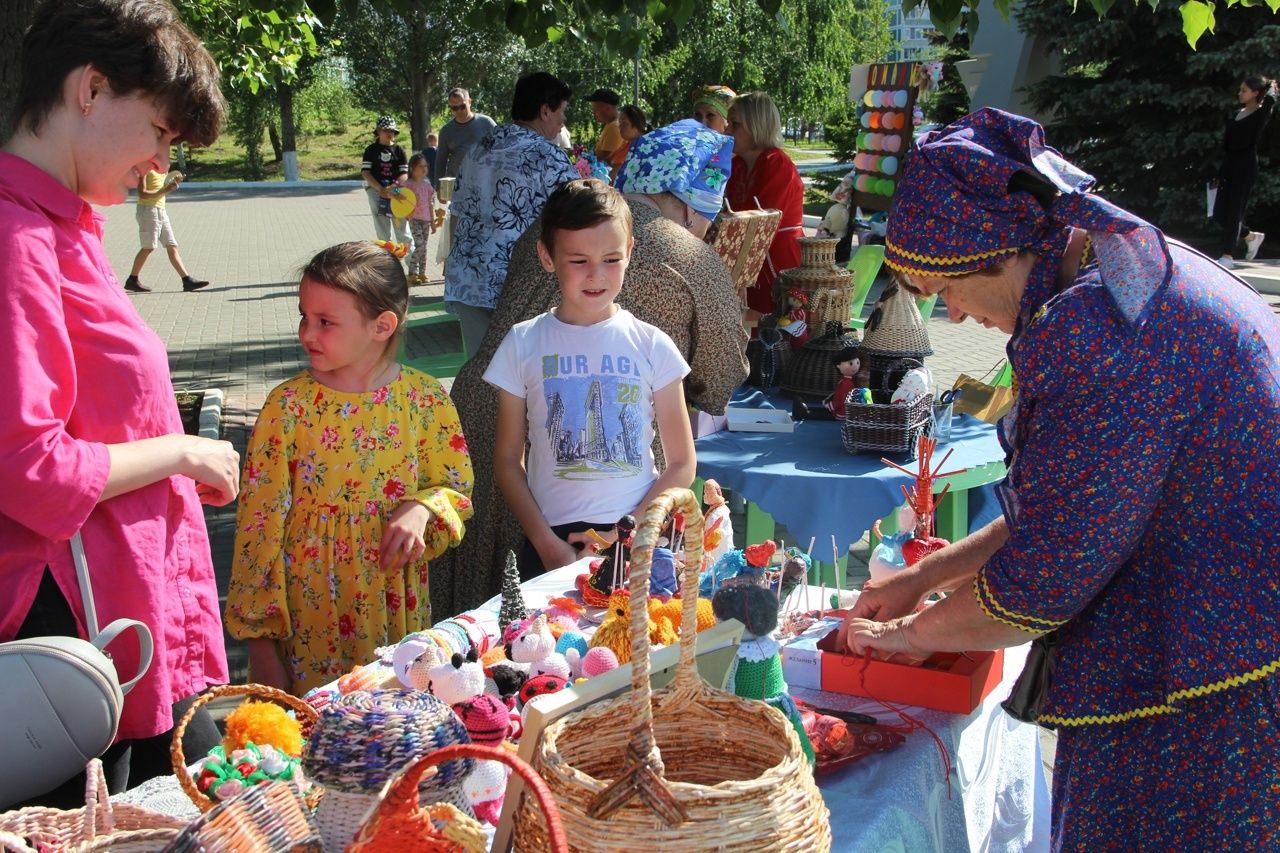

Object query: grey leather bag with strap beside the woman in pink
[0,533,152,811]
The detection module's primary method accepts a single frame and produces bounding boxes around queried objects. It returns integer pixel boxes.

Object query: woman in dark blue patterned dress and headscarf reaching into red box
[841,109,1280,850]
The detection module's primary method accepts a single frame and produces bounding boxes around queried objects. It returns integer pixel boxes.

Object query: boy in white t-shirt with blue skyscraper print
[484,179,695,579]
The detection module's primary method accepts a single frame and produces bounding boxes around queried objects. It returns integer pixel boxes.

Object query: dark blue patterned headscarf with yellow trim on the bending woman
[884,108,1172,325]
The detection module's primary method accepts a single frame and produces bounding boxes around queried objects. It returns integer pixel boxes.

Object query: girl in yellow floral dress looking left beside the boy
[225,242,472,694]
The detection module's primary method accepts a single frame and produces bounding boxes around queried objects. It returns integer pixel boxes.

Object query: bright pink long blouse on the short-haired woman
[0,152,227,739]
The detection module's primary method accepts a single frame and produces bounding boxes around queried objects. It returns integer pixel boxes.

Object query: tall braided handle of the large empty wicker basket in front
[588,488,703,826]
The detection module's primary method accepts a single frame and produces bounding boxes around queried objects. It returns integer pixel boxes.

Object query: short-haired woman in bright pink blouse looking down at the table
[0,0,239,804]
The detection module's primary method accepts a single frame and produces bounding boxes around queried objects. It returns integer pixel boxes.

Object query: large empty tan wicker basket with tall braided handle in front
[515,489,831,853]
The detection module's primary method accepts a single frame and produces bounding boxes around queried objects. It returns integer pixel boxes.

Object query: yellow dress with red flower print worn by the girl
[225,368,472,694]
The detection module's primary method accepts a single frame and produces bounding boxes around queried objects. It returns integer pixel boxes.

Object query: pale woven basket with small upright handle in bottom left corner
[0,758,186,853]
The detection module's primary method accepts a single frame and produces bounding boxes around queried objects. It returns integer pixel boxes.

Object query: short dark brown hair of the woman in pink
[14,0,225,145]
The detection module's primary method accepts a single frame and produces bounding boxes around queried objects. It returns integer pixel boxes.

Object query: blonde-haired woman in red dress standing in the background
[724,92,804,314]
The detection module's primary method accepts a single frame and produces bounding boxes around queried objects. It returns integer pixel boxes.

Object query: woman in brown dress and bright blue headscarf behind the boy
[431,119,748,613]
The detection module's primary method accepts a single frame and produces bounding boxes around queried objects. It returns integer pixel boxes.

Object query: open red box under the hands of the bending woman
[818,631,1005,713]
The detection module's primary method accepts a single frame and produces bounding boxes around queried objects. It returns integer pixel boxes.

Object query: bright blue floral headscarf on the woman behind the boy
[616,119,733,219]
